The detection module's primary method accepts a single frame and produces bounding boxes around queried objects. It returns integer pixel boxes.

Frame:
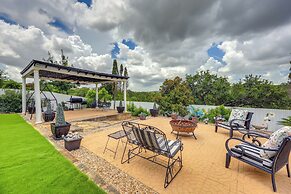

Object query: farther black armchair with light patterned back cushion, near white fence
[215,109,254,137]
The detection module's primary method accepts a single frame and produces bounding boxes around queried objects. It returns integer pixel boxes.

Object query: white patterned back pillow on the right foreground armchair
[260,126,291,159]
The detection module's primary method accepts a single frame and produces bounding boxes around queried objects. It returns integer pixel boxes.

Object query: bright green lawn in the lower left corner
[0,114,105,194]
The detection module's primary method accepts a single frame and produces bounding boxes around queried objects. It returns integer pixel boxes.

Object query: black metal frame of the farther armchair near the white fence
[215,112,254,138]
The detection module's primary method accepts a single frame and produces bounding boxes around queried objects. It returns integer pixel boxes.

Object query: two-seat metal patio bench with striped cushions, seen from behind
[121,121,183,188]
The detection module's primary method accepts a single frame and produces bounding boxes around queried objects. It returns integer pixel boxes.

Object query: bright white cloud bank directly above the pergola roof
[0,21,112,81]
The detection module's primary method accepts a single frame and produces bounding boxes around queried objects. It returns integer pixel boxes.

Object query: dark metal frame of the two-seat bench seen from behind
[121,121,183,188]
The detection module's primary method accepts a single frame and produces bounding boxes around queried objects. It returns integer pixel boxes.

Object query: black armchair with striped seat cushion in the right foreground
[225,132,291,192]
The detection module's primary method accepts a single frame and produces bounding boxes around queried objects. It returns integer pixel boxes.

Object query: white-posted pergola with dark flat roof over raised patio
[20,60,128,123]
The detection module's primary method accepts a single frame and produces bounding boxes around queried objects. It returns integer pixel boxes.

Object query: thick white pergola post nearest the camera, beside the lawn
[33,69,42,123]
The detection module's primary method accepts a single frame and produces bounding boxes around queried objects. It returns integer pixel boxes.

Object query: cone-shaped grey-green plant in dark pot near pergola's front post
[51,103,71,139]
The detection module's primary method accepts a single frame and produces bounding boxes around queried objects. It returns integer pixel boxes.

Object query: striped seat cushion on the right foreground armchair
[231,143,273,168]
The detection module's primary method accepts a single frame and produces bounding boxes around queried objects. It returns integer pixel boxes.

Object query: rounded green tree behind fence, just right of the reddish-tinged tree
[186,71,230,105]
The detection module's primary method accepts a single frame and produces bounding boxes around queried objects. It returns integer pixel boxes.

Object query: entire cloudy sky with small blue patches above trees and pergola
[0,0,291,91]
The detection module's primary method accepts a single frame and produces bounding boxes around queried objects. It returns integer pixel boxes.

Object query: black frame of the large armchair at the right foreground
[225,132,291,192]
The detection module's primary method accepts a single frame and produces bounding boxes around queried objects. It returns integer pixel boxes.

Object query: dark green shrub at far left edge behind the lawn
[0,90,22,113]
